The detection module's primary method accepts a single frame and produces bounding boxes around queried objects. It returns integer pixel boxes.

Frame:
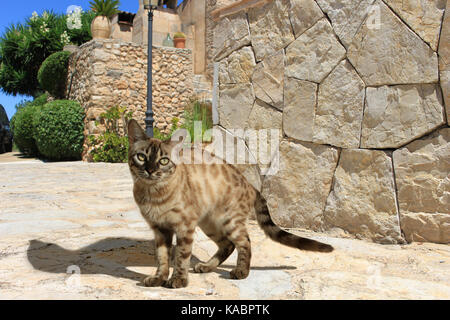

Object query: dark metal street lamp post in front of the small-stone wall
[144,0,159,137]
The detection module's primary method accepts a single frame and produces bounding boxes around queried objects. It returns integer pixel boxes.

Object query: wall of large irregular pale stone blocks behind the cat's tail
[213,0,450,243]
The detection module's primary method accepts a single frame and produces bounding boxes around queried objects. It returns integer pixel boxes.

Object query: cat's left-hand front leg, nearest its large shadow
[144,227,173,287]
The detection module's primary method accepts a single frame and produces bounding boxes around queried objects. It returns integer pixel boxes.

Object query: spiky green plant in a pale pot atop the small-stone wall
[89,0,120,39]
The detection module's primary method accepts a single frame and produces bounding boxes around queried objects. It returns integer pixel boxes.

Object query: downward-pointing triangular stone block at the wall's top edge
[317,0,375,47]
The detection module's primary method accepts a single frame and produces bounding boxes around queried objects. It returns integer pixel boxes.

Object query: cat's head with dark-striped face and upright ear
[128,119,176,184]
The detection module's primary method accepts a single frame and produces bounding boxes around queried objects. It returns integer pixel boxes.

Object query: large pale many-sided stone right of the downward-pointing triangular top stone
[347,0,438,86]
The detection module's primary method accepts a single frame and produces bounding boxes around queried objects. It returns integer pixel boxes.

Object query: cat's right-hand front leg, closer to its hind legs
[165,230,194,288]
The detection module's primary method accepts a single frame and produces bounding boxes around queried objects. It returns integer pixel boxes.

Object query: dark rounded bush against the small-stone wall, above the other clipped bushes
[38,51,71,99]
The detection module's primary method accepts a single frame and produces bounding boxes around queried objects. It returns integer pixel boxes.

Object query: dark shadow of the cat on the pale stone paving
[27,237,296,285]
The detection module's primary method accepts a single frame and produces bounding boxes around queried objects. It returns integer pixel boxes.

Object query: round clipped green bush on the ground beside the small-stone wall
[33,100,84,160]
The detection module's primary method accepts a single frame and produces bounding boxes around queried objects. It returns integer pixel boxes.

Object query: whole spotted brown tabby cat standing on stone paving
[128,120,333,288]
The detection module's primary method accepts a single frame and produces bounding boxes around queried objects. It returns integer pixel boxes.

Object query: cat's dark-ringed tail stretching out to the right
[255,192,333,252]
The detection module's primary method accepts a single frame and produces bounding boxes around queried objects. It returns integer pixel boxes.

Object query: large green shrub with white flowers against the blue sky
[0,11,95,97]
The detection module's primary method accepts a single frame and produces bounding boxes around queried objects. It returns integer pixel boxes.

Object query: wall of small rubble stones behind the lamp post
[67,39,193,160]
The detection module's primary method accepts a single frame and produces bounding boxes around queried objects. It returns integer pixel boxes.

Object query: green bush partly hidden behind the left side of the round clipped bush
[10,102,42,155]
